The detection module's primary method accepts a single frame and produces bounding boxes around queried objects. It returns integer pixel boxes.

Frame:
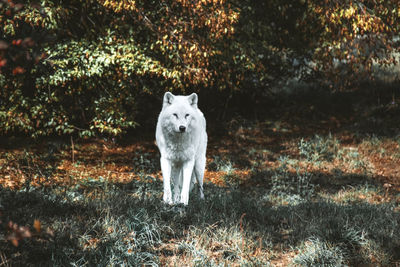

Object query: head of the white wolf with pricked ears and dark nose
[162,92,198,133]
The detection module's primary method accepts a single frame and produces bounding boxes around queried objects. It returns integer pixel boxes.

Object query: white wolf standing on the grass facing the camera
[156,92,207,205]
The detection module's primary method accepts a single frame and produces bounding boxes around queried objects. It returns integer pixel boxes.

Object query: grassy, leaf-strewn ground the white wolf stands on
[0,88,400,266]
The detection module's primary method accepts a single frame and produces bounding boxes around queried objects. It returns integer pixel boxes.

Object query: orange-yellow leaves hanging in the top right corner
[300,0,400,89]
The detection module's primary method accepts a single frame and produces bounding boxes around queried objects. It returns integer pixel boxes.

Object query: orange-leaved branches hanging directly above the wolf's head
[86,0,239,89]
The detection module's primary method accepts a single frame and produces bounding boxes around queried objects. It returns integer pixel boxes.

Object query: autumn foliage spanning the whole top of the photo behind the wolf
[0,0,400,137]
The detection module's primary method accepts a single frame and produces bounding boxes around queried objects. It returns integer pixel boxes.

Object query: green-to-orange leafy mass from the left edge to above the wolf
[0,1,241,136]
